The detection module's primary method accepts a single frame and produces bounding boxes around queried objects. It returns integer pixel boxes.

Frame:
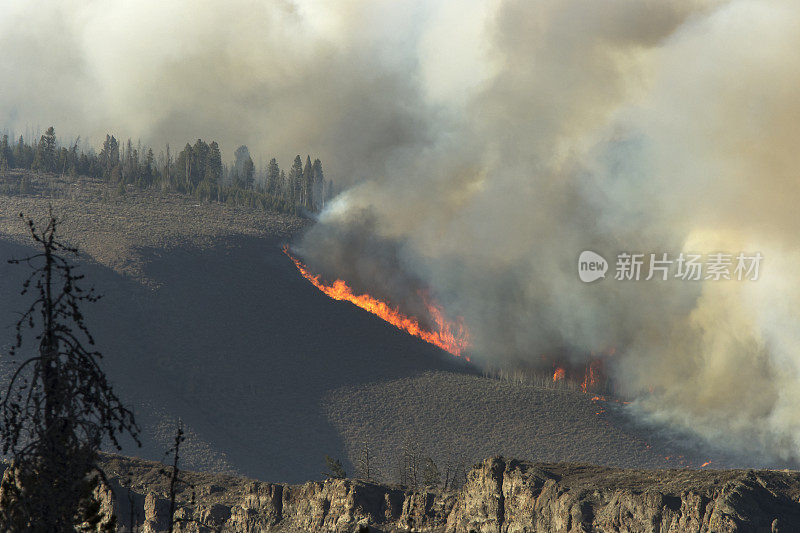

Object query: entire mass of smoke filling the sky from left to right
[6,0,800,459]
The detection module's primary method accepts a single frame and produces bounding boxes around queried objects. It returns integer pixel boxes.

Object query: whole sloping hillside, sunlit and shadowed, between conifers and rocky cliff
[0,173,732,482]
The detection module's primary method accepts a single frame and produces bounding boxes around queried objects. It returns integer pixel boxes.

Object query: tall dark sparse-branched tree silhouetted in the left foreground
[0,209,139,532]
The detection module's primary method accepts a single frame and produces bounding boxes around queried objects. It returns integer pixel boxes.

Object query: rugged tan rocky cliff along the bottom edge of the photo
[95,457,800,533]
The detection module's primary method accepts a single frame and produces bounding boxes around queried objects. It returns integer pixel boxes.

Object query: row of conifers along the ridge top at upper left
[0,126,337,213]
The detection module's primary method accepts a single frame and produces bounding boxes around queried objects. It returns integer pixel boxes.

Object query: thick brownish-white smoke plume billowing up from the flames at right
[303,1,800,460]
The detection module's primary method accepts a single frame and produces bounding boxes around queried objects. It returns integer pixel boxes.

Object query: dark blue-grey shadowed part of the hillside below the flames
[0,234,463,481]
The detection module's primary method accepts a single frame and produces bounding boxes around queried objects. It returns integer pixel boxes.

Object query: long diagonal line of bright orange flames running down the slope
[283,246,469,361]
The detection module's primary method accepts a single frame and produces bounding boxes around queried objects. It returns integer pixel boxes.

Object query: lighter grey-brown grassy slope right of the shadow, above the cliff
[323,372,706,480]
